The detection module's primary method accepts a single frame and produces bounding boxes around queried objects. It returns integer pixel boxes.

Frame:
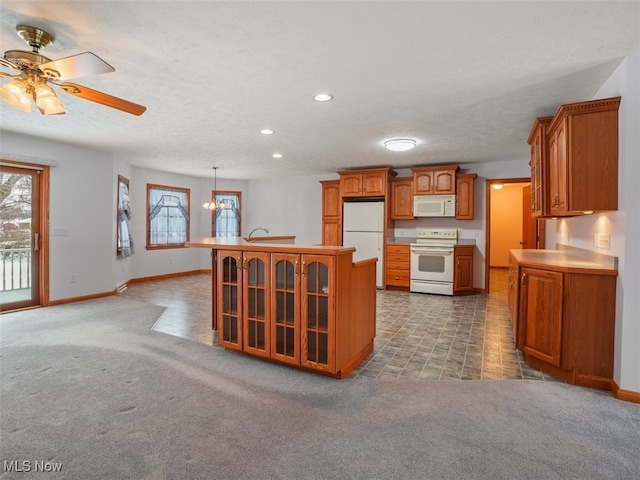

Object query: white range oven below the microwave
[409,228,458,295]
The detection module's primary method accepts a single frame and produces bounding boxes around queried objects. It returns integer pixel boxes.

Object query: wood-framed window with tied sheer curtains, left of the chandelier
[147,183,190,248]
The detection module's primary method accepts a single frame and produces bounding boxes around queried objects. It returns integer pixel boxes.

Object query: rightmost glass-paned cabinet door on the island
[302,255,335,371]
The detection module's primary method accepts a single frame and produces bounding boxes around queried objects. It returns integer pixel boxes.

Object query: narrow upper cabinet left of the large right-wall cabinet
[528,117,553,218]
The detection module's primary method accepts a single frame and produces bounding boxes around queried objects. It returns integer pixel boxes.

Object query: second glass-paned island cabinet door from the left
[243,252,270,356]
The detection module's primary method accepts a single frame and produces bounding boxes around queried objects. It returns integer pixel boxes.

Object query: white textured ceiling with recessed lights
[0,0,640,179]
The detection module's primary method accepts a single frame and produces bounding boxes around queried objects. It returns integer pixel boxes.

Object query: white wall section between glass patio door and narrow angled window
[1,131,115,300]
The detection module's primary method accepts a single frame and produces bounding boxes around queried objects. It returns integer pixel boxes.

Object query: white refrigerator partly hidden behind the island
[342,202,384,288]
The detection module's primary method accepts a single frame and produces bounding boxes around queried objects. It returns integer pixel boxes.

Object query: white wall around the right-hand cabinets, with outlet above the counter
[549,56,640,392]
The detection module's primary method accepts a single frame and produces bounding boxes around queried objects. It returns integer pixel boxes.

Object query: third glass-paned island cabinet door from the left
[271,253,300,365]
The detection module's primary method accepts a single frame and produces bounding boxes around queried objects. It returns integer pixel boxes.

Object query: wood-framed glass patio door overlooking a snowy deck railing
[0,160,49,312]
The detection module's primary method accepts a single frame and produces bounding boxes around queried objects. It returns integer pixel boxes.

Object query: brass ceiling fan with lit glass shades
[0,25,147,115]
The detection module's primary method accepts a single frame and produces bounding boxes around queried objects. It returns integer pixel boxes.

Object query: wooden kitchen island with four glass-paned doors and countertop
[187,237,377,378]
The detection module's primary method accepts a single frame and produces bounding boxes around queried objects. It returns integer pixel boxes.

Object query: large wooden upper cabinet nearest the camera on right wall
[543,97,620,216]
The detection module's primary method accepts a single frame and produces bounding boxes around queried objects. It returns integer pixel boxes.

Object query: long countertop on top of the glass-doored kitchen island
[186,237,356,255]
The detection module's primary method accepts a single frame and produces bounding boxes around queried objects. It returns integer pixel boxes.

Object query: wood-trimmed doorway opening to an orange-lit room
[485,178,544,293]
